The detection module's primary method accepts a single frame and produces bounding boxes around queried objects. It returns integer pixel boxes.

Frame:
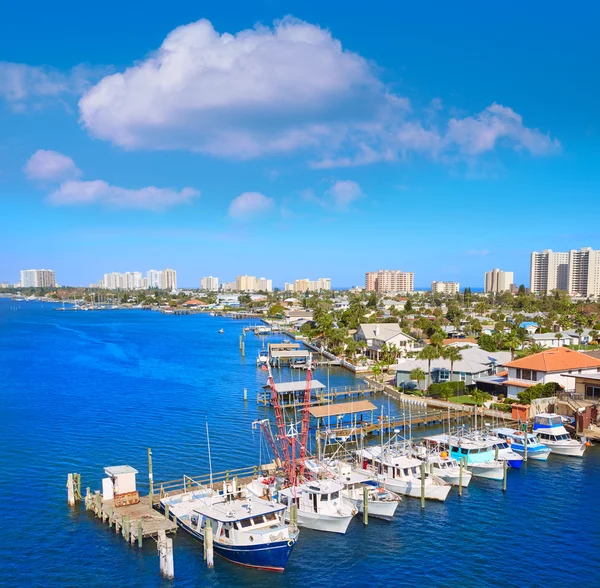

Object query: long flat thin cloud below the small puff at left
[47,180,200,211]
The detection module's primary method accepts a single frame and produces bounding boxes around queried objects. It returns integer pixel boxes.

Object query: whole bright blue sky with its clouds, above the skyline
[0,0,600,287]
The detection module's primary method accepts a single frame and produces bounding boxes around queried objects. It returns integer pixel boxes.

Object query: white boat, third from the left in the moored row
[306,460,402,521]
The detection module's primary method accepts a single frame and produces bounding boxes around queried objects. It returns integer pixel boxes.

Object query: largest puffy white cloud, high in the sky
[80,18,384,157]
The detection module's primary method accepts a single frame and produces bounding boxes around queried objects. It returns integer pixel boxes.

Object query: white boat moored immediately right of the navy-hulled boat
[248,477,357,535]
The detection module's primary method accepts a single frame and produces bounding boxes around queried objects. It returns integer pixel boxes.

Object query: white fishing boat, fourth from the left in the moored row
[356,445,452,502]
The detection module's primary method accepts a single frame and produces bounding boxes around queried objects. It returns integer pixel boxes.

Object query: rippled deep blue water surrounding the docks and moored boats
[0,299,600,588]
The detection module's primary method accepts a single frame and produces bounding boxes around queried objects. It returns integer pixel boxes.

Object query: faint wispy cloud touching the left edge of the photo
[0,61,107,112]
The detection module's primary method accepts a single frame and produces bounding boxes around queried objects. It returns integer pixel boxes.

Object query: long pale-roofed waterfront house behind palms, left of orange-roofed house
[391,345,510,388]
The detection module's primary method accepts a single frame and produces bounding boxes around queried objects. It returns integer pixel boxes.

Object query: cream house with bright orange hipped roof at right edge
[504,347,600,398]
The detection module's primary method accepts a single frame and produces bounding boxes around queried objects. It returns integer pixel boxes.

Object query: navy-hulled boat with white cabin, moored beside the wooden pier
[160,482,298,572]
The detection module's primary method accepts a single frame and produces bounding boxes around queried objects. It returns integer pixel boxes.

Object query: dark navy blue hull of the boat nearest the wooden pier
[177,520,296,572]
